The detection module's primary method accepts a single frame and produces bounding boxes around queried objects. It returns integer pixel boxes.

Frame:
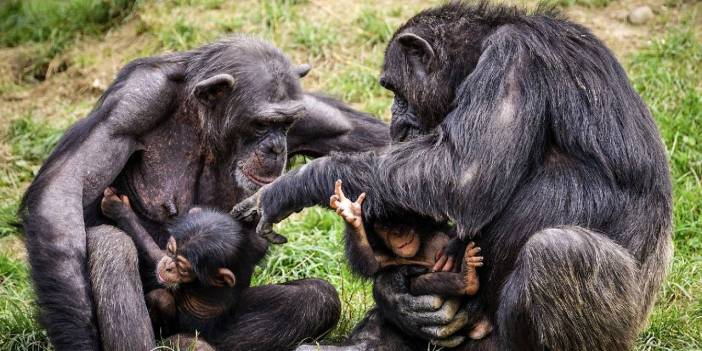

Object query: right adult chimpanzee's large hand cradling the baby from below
[373,266,468,347]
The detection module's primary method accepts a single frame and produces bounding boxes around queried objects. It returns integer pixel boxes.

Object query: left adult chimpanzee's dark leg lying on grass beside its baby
[214,279,341,351]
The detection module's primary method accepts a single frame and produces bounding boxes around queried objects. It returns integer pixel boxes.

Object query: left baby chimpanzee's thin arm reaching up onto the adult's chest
[100,188,165,265]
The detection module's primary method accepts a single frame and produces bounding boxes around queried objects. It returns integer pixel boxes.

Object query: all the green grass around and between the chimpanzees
[0,0,702,351]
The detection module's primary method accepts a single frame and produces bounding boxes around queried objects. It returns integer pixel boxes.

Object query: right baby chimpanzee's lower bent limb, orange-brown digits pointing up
[410,242,483,296]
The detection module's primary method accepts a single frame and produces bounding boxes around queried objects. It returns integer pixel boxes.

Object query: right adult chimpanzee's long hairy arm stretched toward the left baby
[244,26,547,242]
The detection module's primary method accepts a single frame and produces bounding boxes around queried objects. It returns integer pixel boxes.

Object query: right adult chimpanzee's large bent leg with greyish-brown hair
[496,227,642,351]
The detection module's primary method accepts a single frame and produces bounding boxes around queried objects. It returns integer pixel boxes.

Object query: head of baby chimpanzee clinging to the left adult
[156,207,246,289]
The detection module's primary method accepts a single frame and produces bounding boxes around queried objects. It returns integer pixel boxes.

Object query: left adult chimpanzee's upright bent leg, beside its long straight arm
[87,225,156,351]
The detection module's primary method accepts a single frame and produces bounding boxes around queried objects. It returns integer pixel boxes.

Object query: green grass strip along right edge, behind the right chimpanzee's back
[630,28,702,350]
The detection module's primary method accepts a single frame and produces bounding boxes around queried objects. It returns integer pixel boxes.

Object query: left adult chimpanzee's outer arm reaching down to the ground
[20,64,180,350]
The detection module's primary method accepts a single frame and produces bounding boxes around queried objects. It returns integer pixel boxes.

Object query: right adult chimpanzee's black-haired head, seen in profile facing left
[380,3,504,141]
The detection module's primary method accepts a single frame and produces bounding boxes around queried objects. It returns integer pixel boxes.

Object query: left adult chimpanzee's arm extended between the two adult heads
[288,93,390,157]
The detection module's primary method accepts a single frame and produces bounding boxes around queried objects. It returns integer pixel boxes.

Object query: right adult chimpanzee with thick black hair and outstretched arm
[238,3,671,350]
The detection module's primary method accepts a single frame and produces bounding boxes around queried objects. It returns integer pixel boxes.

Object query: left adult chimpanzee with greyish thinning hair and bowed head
[20,37,389,350]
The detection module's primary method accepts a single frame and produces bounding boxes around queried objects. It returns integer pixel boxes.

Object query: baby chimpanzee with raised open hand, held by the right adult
[330,180,492,340]
